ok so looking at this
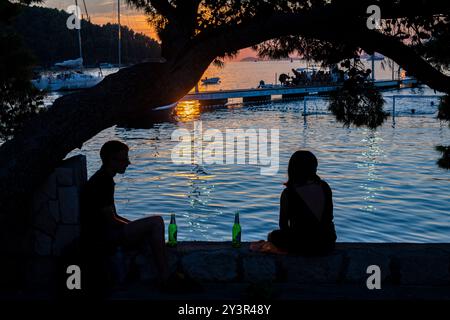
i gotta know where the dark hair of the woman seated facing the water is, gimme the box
[285,150,320,187]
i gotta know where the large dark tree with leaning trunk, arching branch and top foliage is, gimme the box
[0,0,450,284]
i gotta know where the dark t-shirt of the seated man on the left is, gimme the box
[81,167,123,249]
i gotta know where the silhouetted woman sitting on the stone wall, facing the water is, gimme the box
[268,151,336,255]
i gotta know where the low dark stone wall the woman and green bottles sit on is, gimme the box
[138,242,450,292]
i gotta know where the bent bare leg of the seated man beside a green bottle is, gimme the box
[124,216,169,281]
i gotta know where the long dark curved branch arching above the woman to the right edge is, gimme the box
[197,10,450,92]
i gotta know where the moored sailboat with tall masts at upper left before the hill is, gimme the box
[31,0,121,91]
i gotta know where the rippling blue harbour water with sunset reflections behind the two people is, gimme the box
[59,62,450,242]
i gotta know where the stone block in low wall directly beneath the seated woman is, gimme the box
[282,253,343,284]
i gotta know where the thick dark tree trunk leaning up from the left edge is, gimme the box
[0,51,214,255]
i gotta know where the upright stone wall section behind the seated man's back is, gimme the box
[29,155,87,286]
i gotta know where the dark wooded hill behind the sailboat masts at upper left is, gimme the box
[14,6,161,67]
